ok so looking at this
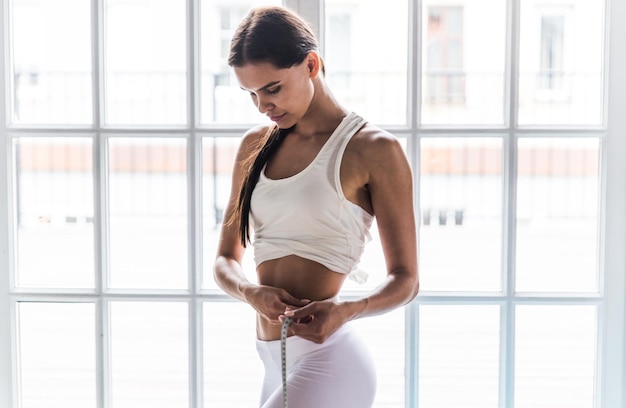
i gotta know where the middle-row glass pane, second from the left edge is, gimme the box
[109,138,188,289]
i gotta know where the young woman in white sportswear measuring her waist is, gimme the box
[214,7,418,408]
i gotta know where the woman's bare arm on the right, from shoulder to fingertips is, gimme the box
[285,128,419,343]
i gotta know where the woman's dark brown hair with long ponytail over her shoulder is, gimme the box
[228,7,324,247]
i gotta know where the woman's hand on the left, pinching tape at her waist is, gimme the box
[244,285,311,324]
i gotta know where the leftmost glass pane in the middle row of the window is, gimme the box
[14,137,95,288]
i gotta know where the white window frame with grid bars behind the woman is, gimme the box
[0,0,626,408]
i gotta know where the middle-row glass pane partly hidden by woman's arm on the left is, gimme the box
[202,137,256,289]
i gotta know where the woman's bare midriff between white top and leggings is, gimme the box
[257,255,346,341]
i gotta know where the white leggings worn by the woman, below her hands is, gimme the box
[257,323,376,408]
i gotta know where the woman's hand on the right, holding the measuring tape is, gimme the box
[279,300,348,344]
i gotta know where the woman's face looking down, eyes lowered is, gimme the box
[234,59,314,129]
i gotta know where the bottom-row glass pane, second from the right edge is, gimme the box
[418,305,500,408]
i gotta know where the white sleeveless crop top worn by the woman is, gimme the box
[250,113,374,283]
